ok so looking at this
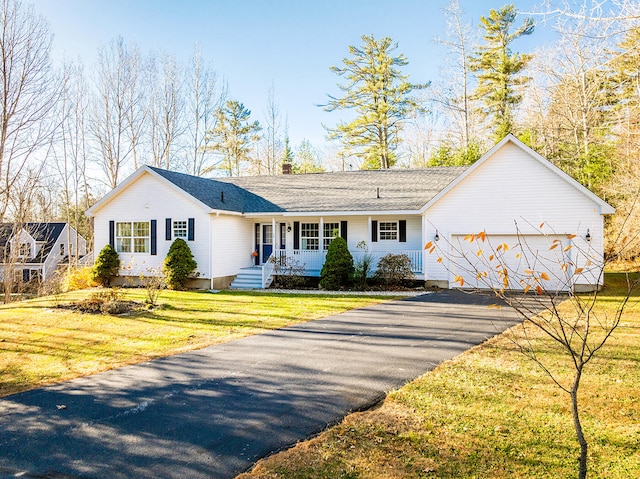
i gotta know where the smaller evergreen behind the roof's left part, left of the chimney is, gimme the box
[207,100,262,176]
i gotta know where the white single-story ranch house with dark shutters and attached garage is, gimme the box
[87,135,614,289]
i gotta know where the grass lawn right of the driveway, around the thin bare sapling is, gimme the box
[239,274,640,479]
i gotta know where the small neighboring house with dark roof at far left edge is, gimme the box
[0,222,87,282]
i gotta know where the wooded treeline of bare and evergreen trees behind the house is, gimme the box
[0,0,640,255]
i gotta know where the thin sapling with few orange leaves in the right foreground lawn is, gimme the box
[425,218,640,479]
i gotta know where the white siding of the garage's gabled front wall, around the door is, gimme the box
[424,143,603,286]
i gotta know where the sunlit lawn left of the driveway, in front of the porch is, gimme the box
[0,289,388,396]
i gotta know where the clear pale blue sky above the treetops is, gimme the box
[31,0,549,150]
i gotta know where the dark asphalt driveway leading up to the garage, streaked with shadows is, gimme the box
[0,291,516,479]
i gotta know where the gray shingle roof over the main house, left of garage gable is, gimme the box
[151,167,466,213]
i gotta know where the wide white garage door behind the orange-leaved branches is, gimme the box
[450,234,571,291]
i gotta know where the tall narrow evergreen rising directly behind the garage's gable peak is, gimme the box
[469,5,534,141]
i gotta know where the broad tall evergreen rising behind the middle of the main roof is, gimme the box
[324,35,426,169]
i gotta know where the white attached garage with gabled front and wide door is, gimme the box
[422,135,614,292]
